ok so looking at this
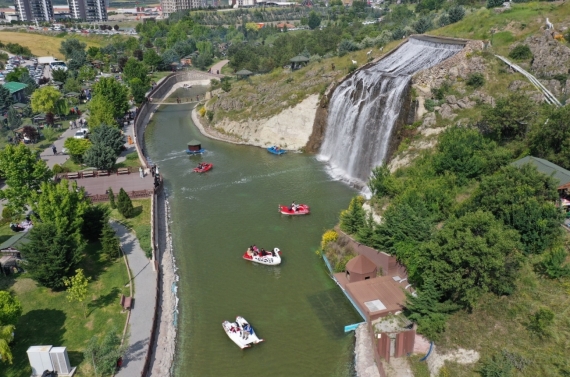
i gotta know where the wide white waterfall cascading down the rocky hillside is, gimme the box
[318,38,463,187]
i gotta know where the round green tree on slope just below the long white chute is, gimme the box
[482,92,538,140]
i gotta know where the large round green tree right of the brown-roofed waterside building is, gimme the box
[413,211,521,308]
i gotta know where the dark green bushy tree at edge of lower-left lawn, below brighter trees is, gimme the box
[21,223,83,289]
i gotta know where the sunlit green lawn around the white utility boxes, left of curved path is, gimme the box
[0,243,129,377]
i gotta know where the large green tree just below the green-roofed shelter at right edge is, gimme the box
[471,164,563,254]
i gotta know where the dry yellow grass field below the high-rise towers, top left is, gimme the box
[0,30,101,59]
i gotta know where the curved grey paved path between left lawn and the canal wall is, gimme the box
[112,223,157,377]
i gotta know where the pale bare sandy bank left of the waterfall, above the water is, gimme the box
[192,94,319,150]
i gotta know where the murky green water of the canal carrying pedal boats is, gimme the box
[145,88,361,377]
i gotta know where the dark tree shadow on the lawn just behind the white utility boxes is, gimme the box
[7,309,66,376]
